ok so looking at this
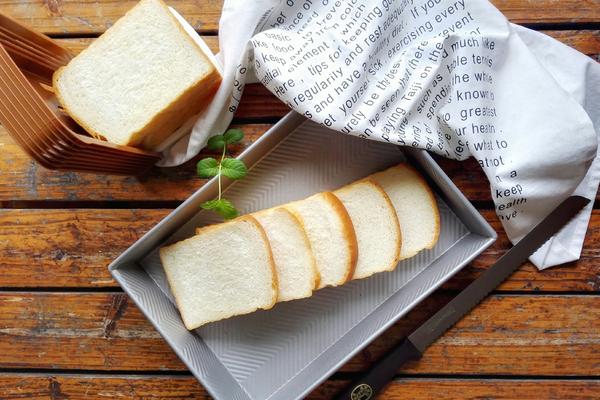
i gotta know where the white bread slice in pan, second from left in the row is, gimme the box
[252,207,320,301]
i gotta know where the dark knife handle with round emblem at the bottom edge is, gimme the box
[336,338,421,400]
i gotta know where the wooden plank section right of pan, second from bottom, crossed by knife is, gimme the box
[344,293,600,376]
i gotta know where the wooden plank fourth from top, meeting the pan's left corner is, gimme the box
[0,209,600,292]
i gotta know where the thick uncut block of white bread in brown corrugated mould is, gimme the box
[53,0,221,150]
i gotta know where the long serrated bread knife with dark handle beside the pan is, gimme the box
[336,196,590,400]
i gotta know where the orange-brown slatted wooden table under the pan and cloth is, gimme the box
[0,0,600,400]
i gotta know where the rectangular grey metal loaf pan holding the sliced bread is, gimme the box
[109,112,496,400]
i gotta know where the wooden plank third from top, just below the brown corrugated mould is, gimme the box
[0,125,600,203]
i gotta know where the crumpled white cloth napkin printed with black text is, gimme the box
[162,0,600,269]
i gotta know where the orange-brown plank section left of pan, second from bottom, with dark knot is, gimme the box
[0,293,184,371]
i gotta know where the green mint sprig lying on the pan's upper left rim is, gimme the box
[196,129,248,219]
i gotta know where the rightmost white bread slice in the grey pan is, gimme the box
[370,164,440,259]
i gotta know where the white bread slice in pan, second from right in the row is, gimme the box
[333,180,402,279]
